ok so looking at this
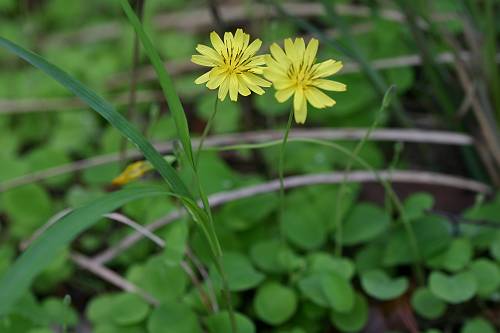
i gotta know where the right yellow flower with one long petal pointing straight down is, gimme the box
[264,38,346,124]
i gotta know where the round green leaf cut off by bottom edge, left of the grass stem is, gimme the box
[147,302,202,333]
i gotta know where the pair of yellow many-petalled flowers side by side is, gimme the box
[191,29,346,124]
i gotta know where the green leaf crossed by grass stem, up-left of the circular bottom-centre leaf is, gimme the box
[212,251,265,291]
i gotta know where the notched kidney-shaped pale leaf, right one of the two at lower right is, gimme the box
[429,271,477,304]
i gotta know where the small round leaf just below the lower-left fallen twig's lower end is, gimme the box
[111,293,149,326]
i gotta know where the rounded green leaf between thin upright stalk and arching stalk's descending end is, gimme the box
[342,203,390,245]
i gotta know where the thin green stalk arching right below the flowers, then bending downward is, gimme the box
[206,138,424,285]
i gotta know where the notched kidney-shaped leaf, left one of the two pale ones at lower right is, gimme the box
[361,269,408,301]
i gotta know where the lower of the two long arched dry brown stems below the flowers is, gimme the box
[94,170,491,264]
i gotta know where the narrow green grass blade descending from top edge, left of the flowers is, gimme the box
[121,0,195,169]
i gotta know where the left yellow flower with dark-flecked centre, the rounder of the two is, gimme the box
[191,29,271,101]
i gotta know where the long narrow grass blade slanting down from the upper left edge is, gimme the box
[0,37,192,199]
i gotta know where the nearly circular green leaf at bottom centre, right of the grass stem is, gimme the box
[253,283,297,326]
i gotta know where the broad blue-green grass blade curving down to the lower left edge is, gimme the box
[0,187,168,315]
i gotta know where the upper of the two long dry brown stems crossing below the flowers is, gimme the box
[0,128,474,193]
